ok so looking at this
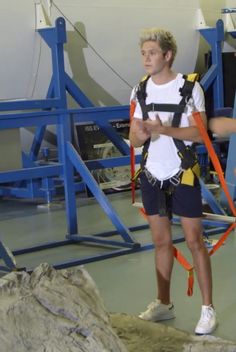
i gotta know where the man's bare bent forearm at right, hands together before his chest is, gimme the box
[143,112,207,143]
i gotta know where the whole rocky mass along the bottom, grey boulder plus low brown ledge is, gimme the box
[0,264,236,352]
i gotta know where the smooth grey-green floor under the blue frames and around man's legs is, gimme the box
[0,192,236,341]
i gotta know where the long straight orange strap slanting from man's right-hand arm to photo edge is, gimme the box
[193,112,236,216]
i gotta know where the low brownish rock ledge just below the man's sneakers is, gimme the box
[111,314,236,352]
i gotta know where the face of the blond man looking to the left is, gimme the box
[141,40,170,76]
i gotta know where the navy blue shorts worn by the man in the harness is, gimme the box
[140,172,203,218]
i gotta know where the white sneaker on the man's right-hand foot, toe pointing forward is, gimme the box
[195,306,217,335]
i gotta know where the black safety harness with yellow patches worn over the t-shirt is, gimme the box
[135,75,199,218]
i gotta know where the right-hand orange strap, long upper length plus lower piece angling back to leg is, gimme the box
[193,112,236,255]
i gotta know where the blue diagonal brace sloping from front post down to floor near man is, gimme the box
[67,143,135,243]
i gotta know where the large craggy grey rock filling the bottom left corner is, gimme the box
[0,264,127,352]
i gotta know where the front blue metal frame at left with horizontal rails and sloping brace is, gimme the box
[0,107,141,265]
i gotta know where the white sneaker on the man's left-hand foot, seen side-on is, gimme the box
[139,299,175,321]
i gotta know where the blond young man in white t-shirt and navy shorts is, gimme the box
[129,28,217,334]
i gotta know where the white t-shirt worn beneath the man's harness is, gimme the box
[131,73,205,181]
